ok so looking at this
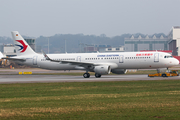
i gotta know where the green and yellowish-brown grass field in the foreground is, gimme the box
[0,80,180,120]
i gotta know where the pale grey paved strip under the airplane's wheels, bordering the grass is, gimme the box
[0,75,180,84]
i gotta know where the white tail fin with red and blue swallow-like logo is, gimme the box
[11,31,36,56]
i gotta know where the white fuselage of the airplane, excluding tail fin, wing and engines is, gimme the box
[17,52,179,70]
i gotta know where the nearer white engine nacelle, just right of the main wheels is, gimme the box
[94,66,111,75]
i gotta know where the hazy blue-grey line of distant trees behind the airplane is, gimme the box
[0,33,165,53]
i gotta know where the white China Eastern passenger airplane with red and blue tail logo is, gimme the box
[2,31,179,78]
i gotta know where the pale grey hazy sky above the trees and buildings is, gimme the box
[0,0,180,37]
